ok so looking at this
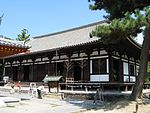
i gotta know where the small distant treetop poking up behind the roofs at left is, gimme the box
[16,29,30,43]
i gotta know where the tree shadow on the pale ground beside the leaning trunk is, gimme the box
[62,97,136,111]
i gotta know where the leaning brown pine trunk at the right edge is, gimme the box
[130,27,150,100]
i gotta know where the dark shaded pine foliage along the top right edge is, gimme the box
[88,0,150,20]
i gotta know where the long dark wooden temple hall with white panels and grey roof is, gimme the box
[0,21,143,91]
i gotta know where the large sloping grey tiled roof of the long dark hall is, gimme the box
[28,21,105,52]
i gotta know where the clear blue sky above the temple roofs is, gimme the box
[0,0,105,39]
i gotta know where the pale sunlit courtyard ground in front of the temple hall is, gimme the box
[0,88,150,113]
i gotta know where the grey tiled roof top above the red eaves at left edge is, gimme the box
[0,37,29,48]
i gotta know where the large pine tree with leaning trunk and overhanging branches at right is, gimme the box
[90,0,150,100]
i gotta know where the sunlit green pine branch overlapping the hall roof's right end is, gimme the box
[91,7,150,44]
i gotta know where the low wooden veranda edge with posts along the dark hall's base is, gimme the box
[59,82,134,91]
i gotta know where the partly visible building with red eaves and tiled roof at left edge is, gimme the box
[0,37,29,83]
